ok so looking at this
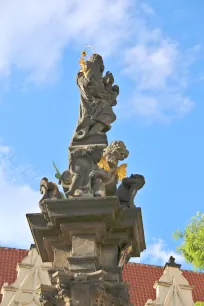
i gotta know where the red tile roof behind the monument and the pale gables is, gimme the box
[0,247,204,306]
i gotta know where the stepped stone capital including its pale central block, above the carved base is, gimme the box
[27,197,145,269]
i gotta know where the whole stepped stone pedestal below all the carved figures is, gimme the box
[27,197,145,306]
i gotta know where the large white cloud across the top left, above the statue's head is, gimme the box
[0,0,131,81]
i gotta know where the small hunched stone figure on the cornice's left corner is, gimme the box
[39,177,62,203]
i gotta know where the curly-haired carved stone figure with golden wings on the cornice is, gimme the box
[90,141,129,196]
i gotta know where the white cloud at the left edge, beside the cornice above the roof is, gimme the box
[0,141,40,248]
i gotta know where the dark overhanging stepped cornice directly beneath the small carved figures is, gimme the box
[27,197,145,261]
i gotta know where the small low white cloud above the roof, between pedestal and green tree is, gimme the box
[131,239,185,265]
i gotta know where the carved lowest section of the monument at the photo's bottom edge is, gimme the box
[38,271,131,306]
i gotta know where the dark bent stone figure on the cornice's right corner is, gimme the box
[116,174,145,207]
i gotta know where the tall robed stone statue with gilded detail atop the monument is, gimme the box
[71,54,119,146]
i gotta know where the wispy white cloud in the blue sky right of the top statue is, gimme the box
[123,11,200,122]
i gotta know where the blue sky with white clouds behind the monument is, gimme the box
[0,0,204,268]
